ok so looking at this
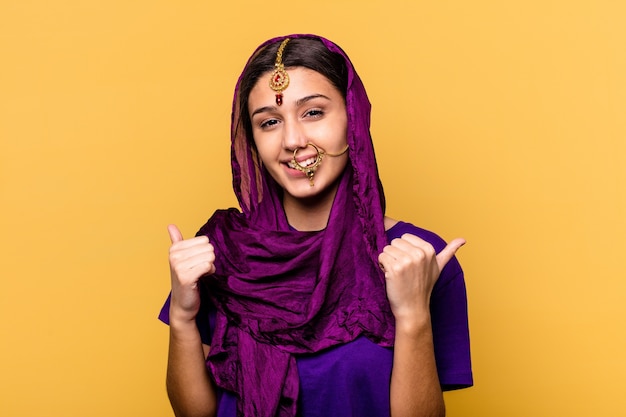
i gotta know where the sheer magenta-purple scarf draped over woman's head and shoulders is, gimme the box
[198,35,394,417]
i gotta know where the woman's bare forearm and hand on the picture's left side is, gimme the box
[166,225,217,417]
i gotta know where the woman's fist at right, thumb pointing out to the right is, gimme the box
[378,233,465,322]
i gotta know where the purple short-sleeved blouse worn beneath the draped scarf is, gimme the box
[159,222,473,417]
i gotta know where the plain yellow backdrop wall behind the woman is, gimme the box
[0,0,626,417]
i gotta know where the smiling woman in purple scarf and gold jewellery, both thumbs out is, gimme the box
[161,35,472,417]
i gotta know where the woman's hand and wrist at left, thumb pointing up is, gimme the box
[167,224,215,322]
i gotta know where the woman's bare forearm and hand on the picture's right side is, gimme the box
[379,234,465,417]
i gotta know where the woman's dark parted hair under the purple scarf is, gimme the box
[237,38,348,142]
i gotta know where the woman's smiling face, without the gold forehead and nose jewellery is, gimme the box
[248,67,348,204]
